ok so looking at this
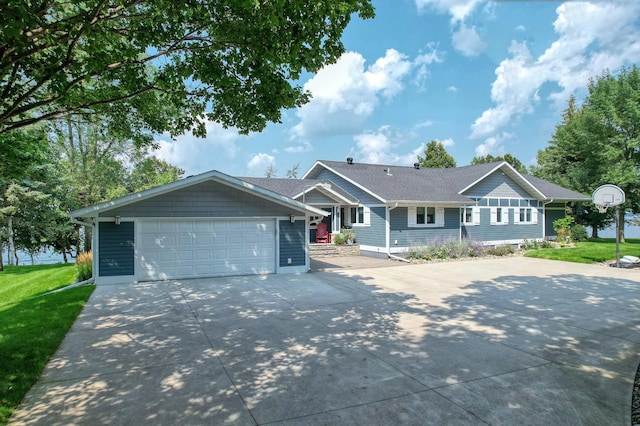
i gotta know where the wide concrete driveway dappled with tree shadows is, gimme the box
[12,257,640,425]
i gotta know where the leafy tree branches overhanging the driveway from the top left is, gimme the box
[0,0,374,142]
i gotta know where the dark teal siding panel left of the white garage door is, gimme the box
[98,222,134,277]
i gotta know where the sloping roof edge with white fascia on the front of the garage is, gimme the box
[70,170,328,218]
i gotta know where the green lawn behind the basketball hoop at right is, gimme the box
[525,238,640,263]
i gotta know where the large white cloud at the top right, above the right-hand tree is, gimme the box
[471,2,640,138]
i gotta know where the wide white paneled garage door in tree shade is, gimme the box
[138,219,276,281]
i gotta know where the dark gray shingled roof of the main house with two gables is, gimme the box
[303,160,590,205]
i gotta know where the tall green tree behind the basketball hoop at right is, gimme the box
[536,66,640,241]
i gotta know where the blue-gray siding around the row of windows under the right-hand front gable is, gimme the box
[462,208,543,242]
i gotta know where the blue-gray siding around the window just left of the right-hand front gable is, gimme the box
[390,207,460,247]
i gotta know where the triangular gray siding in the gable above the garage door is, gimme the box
[104,181,294,217]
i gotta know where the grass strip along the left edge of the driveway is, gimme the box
[0,264,93,425]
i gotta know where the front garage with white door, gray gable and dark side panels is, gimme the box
[71,170,327,285]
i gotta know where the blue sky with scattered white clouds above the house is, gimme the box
[155,0,640,177]
